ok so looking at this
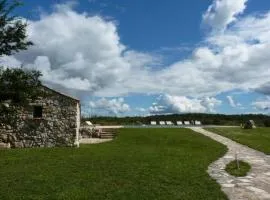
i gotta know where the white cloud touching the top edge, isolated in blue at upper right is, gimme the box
[203,0,247,30]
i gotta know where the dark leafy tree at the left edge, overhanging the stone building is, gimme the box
[0,0,41,125]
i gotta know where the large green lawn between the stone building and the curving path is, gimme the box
[0,129,227,200]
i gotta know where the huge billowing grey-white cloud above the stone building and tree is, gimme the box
[2,4,156,97]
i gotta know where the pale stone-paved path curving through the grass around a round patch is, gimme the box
[190,127,270,200]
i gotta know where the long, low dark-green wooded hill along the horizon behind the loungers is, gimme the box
[82,113,270,126]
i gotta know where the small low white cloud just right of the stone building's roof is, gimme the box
[89,98,130,115]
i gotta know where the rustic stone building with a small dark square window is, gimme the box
[0,86,80,148]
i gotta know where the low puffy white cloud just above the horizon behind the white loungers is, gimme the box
[149,94,221,114]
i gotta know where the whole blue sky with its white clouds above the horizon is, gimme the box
[3,0,270,116]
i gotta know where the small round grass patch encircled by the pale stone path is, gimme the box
[225,160,251,177]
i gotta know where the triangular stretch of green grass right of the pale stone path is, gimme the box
[206,127,270,154]
